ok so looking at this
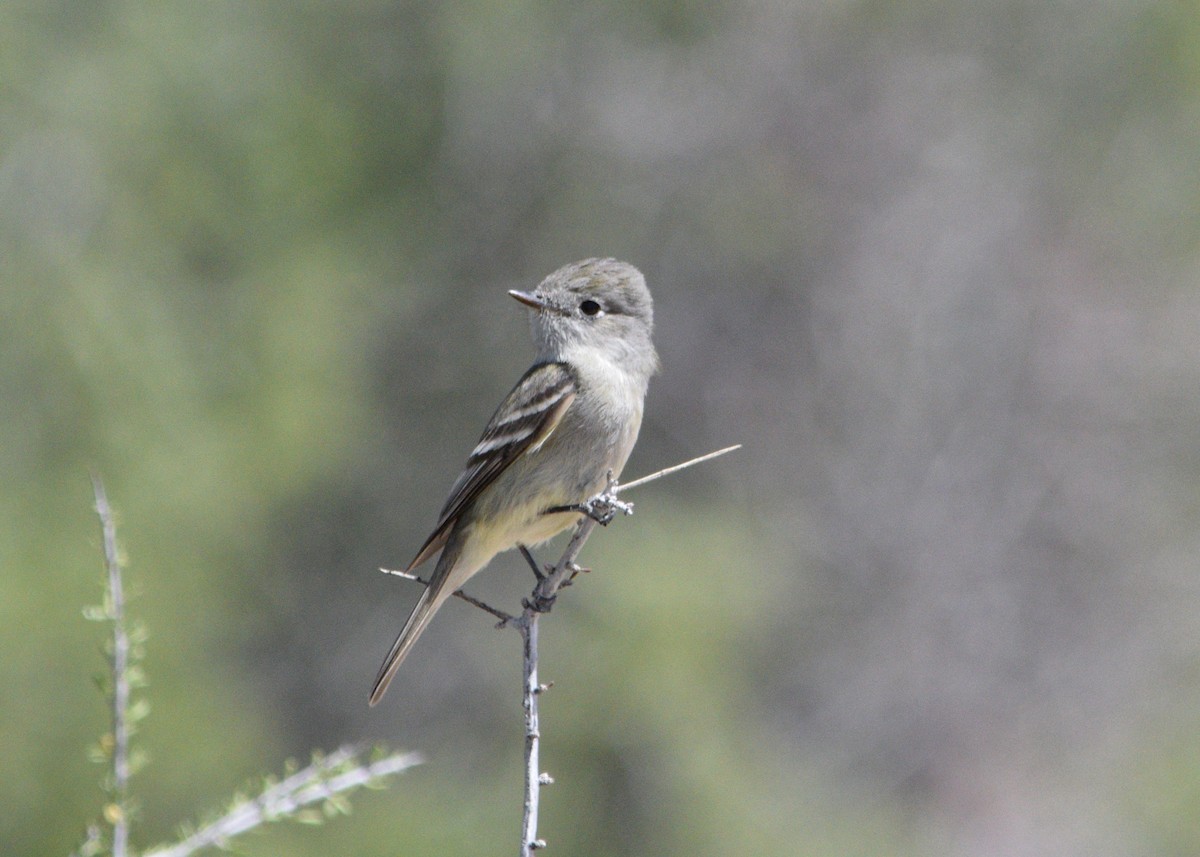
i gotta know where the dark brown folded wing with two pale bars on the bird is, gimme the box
[408,362,578,571]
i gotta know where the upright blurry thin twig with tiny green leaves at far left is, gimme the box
[91,474,130,857]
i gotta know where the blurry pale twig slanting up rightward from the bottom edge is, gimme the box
[145,747,421,857]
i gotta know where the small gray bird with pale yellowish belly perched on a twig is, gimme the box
[371,259,659,706]
